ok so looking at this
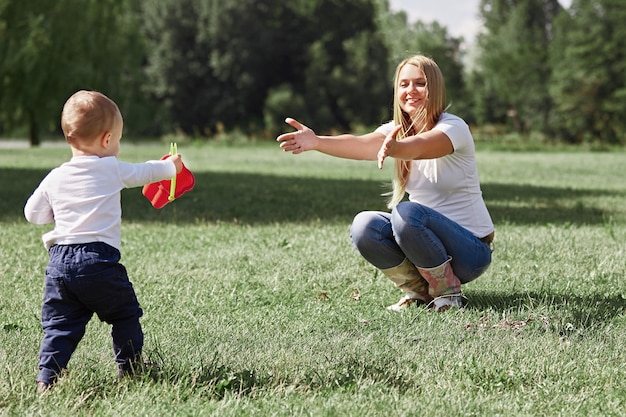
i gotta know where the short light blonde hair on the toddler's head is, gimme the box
[61,90,122,144]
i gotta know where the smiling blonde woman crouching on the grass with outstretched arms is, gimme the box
[276,55,494,311]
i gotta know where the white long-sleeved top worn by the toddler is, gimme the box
[24,156,176,250]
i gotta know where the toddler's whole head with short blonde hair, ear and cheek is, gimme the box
[61,90,123,156]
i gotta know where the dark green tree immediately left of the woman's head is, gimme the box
[298,0,391,131]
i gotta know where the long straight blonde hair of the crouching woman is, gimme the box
[387,55,446,208]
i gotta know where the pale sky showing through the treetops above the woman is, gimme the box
[389,0,572,43]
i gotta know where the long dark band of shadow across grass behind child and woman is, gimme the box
[0,168,619,225]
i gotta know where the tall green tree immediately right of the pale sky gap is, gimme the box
[472,0,561,133]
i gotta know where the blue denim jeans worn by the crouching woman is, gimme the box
[350,201,491,284]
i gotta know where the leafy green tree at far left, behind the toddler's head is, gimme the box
[0,0,144,146]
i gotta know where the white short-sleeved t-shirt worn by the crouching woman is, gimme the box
[376,113,494,238]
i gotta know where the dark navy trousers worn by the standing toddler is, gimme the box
[37,242,143,384]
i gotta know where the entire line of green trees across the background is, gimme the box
[0,0,626,145]
